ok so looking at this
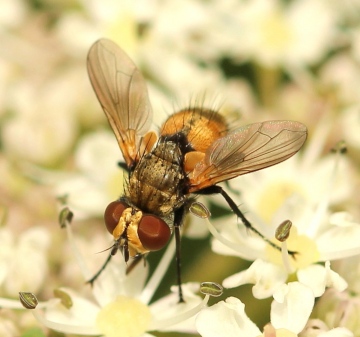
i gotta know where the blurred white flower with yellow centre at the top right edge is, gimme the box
[234,0,336,67]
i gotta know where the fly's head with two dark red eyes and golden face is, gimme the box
[104,200,171,262]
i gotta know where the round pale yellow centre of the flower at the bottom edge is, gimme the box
[96,296,151,337]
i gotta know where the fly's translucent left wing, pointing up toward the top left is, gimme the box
[87,39,152,167]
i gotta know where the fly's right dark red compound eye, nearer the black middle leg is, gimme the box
[138,215,171,250]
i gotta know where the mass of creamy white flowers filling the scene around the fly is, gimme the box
[0,0,360,337]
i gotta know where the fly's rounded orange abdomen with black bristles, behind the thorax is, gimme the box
[160,108,228,152]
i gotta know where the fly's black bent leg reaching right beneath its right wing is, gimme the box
[196,185,296,257]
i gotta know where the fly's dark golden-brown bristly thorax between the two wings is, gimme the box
[125,139,187,216]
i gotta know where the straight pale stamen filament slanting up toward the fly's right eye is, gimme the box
[140,237,175,303]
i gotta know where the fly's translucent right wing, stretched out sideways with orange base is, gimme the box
[189,121,307,192]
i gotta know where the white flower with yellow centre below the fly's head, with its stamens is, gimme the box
[0,219,209,337]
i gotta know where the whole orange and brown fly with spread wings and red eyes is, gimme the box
[87,39,307,302]
